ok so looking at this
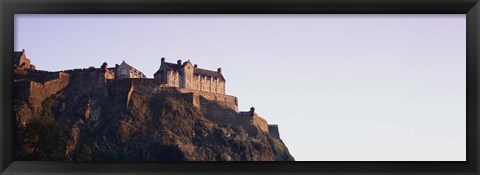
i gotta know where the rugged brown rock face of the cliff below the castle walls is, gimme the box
[15,76,294,161]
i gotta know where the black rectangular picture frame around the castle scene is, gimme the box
[0,0,480,175]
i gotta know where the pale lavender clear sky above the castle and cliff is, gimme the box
[14,14,466,161]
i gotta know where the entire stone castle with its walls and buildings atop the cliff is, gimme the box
[14,50,280,138]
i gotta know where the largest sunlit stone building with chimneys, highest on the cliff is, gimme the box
[154,58,225,94]
